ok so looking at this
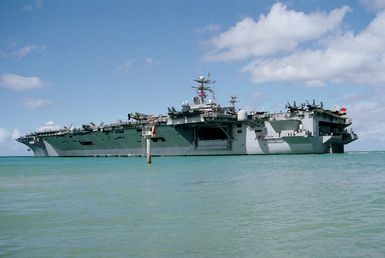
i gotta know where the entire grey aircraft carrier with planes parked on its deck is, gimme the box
[17,76,358,157]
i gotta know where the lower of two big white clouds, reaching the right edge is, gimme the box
[242,12,385,85]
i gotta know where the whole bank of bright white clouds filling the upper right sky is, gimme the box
[203,3,385,87]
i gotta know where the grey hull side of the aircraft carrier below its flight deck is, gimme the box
[18,121,355,157]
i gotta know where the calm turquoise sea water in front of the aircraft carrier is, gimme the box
[0,152,385,257]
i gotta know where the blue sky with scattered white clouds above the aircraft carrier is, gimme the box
[0,0,385,156]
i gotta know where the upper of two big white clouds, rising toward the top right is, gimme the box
[203,3,351,61]
